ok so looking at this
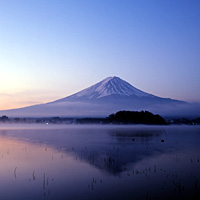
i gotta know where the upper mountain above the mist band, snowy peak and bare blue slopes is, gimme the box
[50,76,184,109]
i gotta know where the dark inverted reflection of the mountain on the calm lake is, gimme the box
[0,126,166,175]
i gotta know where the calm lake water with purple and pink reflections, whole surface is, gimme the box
[0,124,200,200]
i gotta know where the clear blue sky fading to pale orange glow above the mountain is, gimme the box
[0,0,200,110]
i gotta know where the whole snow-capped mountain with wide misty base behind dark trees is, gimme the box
[0,77,197,117]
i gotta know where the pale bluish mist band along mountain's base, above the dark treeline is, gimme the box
[0,102,200,118]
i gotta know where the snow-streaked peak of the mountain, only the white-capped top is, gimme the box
[70,76,153,99]
